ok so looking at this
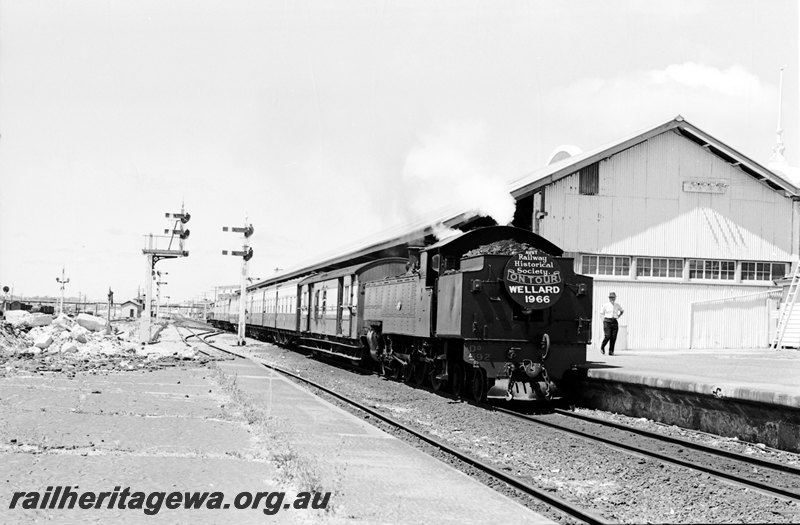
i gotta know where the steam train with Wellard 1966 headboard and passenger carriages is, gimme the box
[208,226,592,402]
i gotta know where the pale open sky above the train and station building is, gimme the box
[0,0,800,302]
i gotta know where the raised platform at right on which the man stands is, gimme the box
[578,349,800,452]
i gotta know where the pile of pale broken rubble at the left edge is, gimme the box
[0,311,204,377]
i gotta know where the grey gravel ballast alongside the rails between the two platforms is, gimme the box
[212,335,800,523]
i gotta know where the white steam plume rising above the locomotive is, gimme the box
[402,124,515,235]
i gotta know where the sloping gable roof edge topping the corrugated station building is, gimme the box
[510,115,800,199]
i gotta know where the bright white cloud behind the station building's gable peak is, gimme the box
[544,62,777,161]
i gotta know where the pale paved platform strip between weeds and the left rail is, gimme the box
[215,348,553,524]
